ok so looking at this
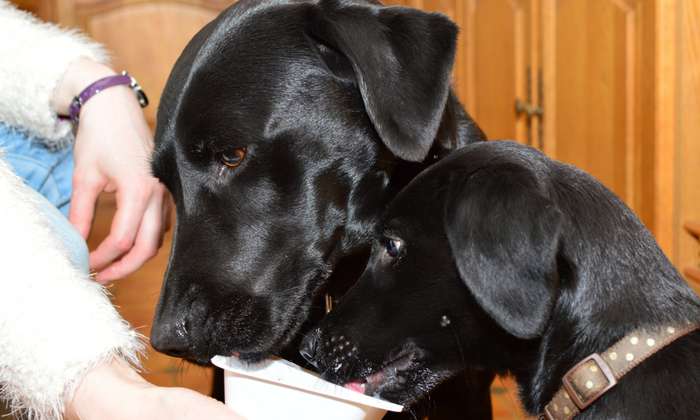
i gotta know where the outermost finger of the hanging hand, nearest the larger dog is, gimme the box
[96,194,164,284]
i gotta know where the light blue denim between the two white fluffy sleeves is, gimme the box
[0,123,89,272]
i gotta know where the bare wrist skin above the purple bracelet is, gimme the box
[51,58,116,115]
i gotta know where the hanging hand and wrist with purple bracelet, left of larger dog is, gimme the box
[53,59,170,283]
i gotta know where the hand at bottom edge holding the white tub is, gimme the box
[65,359,241,420]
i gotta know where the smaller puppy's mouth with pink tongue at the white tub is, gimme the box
[343,350,418,397]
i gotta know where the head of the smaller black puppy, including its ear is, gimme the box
[302,142,562,404]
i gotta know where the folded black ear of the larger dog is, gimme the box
[312,0,458,161]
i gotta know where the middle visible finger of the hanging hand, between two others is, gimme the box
[90,181,152,271]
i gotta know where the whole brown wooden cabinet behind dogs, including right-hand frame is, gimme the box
[387,0,700,289]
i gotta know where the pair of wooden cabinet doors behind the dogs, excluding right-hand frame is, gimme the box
[404,0,654,225]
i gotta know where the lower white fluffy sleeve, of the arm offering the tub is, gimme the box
[0,154,142,420]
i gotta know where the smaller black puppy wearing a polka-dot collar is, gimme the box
[303,142,700,420]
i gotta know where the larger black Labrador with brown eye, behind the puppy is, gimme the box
[151,0,493,418]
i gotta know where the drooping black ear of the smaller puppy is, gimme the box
[444,165,562,338]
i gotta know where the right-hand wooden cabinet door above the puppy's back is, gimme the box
[541,0,654,226]
